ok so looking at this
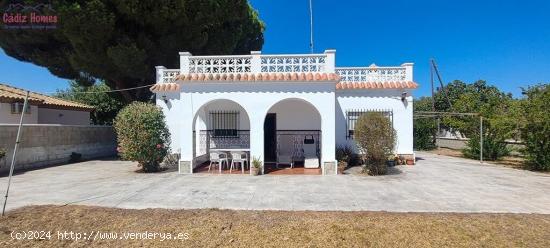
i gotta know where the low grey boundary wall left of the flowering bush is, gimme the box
[0,124,116,173]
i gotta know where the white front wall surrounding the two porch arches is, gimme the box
[157,82,336,174]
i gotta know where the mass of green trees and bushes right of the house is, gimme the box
[414,80,550,170]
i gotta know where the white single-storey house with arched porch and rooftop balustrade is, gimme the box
[151,50,418,174]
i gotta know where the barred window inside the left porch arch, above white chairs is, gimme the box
[210,110,240,137]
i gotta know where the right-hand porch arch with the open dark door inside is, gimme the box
[264,98,322,174]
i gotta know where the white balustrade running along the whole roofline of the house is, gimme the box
[157,50,413,83]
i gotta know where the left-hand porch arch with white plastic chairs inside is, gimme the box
[193,99,250,173]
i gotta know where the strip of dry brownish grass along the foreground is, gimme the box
[0,206,550,247]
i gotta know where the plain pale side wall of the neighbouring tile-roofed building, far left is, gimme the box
[38,108,90,125]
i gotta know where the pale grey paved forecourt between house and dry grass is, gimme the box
[0,153,550,214]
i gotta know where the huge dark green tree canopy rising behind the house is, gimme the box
[0,0,264,101]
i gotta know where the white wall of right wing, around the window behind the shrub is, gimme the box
[336,90,414,154]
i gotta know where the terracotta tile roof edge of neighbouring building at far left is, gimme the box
[0,83,94,111]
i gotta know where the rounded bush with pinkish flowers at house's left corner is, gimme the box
[114,102,170,172]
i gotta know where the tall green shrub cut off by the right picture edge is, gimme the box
[521,84,550,171]
